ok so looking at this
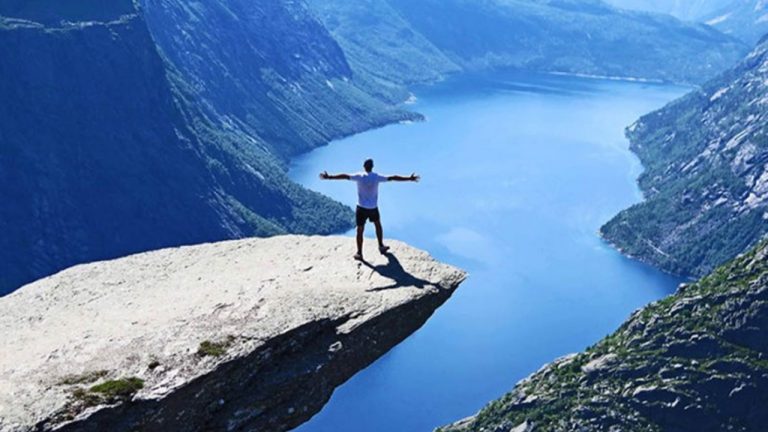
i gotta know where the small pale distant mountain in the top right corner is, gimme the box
[702,0,768,44]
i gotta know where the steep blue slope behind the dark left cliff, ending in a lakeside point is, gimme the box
[142,0,414,157]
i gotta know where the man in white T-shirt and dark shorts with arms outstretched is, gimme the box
[320,159,419,261]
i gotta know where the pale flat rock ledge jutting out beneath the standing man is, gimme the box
[0,236,465,432]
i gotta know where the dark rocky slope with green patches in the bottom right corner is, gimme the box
[442,244,768,432]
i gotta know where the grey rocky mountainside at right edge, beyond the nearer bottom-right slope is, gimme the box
[601,40,768,275]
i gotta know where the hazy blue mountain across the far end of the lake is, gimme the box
[311,0,746,83]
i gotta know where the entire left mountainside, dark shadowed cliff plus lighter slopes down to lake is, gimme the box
[0,0,414,294]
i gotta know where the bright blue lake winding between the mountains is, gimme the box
[290,74,687,432]
